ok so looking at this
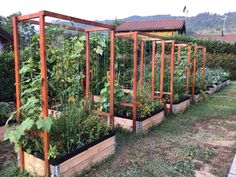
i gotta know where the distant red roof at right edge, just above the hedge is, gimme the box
[195,34,236,42]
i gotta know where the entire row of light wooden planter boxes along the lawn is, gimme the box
[0,80,230,176]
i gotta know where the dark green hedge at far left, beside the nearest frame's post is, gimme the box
[0,46,15,102]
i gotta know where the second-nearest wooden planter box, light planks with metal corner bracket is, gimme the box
[114,111,165,133]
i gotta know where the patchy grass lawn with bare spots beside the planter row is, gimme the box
[0,82,236,177]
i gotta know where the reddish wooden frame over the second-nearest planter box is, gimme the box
[115,31,168,132]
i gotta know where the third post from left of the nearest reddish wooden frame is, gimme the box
[85,31,90,111]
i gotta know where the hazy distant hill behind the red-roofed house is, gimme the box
[102,12,236,34]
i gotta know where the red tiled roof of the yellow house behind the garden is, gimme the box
[116,20,185,32]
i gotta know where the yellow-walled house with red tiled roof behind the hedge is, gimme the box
[116,20,186,36]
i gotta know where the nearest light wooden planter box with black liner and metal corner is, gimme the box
[21,132,116,177]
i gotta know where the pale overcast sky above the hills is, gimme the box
[0,0,236,20]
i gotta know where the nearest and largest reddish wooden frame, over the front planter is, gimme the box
[12,11,115,177]
